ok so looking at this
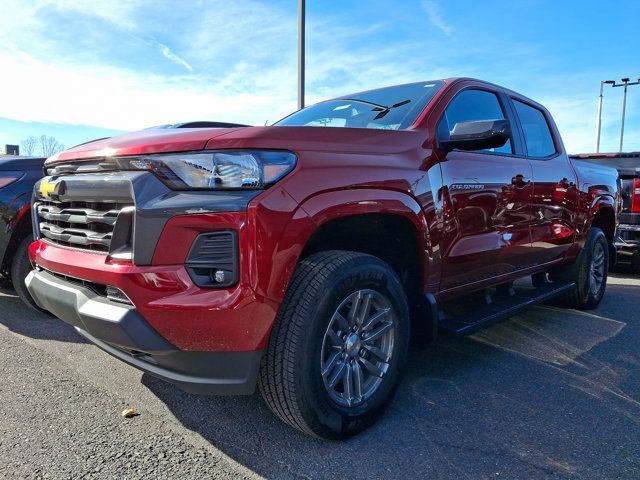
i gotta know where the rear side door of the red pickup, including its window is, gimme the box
[511,98,579,263]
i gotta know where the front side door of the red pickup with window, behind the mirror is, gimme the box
[436,86,533,290]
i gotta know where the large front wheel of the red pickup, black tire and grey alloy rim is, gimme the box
[258,250,410,439]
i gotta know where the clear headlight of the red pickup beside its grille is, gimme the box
[117,150,296,190]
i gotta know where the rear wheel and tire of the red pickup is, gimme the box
[551,227,609,310]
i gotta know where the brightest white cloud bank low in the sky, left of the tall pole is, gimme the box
[0,49,294,130]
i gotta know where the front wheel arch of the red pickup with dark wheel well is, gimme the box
[256,189,431,342]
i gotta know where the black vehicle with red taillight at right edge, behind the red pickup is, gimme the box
[572,152,640,274]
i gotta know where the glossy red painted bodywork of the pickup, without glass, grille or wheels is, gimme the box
[36,79,617,351]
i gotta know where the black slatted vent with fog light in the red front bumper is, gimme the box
[186,230,238,288]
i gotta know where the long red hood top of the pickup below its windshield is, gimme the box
[47,126,424,164]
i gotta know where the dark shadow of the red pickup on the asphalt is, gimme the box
[142,287,640,479]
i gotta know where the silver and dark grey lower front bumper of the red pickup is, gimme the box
[26,270,262,395]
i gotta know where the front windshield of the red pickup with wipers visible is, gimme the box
[275,81,442,130]
